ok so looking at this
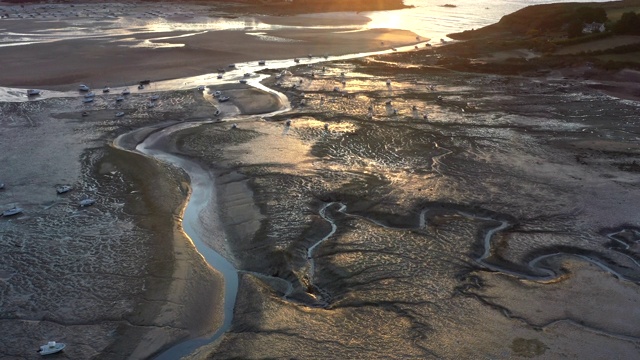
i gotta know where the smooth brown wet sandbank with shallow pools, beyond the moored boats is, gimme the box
[0,5,416,90]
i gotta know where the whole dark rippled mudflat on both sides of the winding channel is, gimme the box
[0,1,640,359]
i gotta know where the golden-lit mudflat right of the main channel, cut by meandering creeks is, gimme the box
[158,52,640,359]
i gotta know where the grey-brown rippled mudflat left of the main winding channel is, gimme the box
[0,86,222,359]
